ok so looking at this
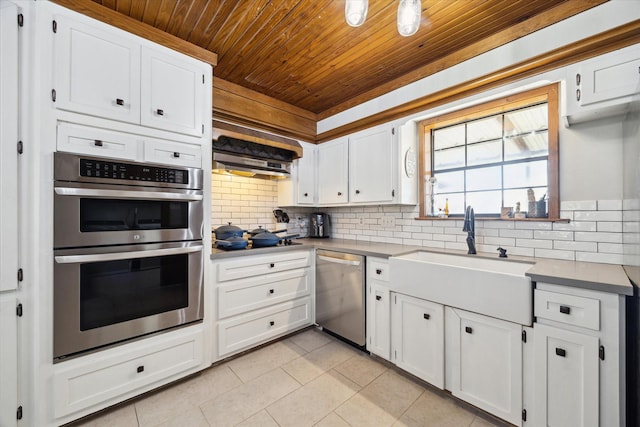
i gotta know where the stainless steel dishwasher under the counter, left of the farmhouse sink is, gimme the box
[316,249,366,347]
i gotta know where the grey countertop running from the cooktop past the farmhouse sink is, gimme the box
[211,238,633,295]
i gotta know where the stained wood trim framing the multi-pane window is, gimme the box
[416,83,567,222]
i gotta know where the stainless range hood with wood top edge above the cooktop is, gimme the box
[212,122,302,179]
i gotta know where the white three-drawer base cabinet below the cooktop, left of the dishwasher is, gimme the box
[214,250,315,360]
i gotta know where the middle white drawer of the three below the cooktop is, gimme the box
[218,268,311,319]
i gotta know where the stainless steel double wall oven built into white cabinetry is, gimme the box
[53,153,204,361]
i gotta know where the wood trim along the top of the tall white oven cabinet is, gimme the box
[53,0,218,67]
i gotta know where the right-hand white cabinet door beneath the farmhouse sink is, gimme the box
[445,307,522,425]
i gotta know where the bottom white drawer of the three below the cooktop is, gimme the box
[218,297,311,356]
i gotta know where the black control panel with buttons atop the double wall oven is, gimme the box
[80,159,189,184]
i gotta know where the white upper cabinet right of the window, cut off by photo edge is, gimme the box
[563,45,640,125]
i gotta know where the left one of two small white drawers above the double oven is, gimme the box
[56,123,138,160]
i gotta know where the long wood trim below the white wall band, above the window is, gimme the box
[316,20,640,143]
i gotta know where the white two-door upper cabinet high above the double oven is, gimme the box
[52,15,211,137]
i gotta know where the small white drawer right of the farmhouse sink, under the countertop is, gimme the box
[534,289,600,331]
